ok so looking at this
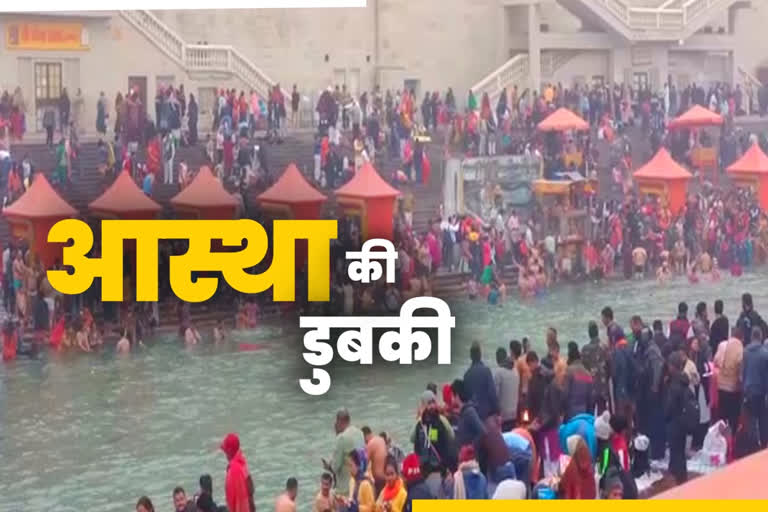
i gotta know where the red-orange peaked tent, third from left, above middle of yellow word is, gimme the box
[171,166,238,220]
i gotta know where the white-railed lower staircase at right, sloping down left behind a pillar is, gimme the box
[472,50,579,105]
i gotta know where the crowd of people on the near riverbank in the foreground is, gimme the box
[132,294,768,512]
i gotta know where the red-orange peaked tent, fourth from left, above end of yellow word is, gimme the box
[257,163,327,219]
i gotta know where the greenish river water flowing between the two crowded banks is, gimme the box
[0,274,768,512]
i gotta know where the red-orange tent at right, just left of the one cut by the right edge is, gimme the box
[632,148,693,214]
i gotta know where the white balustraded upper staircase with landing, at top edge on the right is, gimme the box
[558,0,739,41]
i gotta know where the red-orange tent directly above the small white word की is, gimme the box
[335,162,400,241]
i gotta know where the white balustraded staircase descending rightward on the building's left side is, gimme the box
[120,10,275,96]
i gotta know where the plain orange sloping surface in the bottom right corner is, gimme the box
[654,450,768,500]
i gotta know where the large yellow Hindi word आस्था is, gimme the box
[48,219,338,302]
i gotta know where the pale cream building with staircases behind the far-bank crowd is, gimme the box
[0,0,768,131]
